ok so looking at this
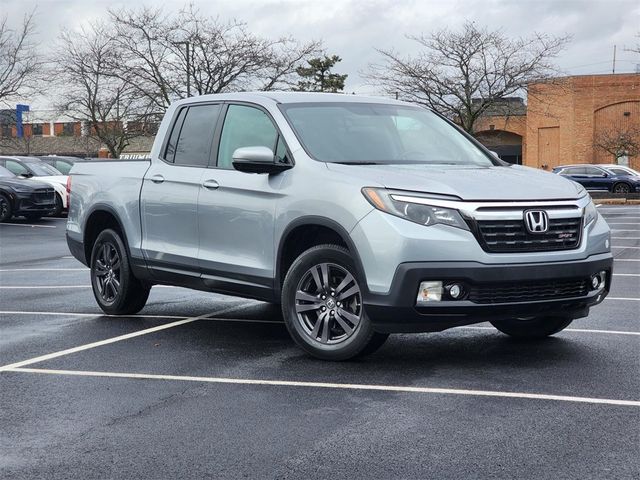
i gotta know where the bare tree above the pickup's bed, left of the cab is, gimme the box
[53,23,147,158]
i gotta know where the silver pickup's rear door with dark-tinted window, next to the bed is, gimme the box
[140,103,222,278]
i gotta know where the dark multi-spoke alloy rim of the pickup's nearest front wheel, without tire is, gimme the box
[295,263,363,345]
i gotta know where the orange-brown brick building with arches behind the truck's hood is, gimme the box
[476,74,640,170]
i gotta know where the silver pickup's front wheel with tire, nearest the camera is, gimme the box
[282,245,388,361]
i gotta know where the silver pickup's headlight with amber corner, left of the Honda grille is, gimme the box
[362,187,469,230]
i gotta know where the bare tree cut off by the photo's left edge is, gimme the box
[0,11,43,103]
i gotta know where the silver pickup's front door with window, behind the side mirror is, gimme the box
[198,104,290,297]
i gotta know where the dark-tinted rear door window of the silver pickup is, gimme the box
[166,105,221,167]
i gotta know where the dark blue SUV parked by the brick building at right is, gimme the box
[553,165,640,193]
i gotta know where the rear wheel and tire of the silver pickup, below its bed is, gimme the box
[91,229,151,315]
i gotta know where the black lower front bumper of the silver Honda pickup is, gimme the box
[364,253,613,333]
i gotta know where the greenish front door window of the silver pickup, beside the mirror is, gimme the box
[218,105,278,169]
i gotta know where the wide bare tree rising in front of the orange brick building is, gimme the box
[363,23,569,132]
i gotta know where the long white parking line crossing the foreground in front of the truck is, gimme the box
[7,367,640,407]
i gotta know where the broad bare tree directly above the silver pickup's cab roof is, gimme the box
[110,5,322,112]
